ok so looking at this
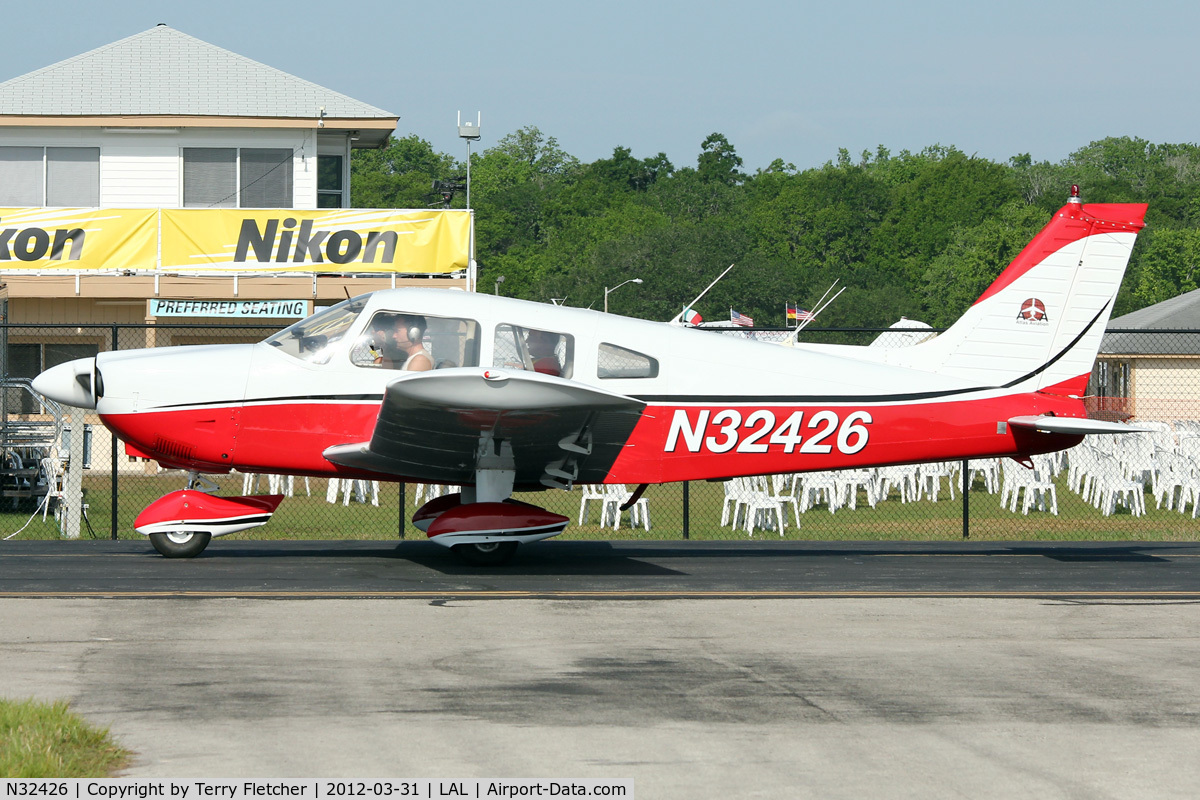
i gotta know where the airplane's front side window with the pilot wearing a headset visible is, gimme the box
[350,311,479,372]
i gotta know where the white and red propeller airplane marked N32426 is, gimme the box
[34,191,1146,564]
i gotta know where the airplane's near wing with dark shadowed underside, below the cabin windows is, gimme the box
[324,367,646,489]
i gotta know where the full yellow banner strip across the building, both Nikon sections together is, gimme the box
[0,207,470,275]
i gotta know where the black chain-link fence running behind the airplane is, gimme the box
[0,325,1200,541]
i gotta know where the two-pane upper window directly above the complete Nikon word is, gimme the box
[184,148,293,209]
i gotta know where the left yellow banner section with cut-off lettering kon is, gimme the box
[0,207,158,272]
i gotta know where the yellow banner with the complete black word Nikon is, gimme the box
[160,209,470,273]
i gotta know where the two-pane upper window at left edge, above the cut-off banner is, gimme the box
[0,148,100,207]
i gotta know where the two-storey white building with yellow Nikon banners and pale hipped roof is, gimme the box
[0,25,472,467]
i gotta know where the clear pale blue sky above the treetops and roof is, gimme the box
[7,0,1200,172]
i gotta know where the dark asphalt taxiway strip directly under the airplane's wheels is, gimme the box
[0,540,1200,600]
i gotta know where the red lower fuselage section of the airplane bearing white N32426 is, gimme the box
[103,393,1085,483]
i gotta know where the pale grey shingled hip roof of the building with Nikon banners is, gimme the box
[0,25,398,142]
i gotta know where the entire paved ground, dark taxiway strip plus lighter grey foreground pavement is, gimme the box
[0,541,1200,800]
